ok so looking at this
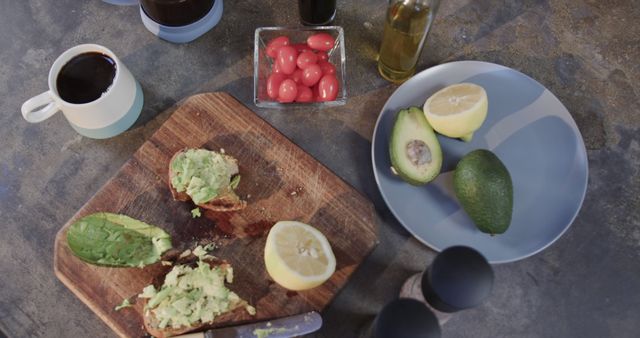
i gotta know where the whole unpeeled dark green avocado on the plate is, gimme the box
[453,149,513,235]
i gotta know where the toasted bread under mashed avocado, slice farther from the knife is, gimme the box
[169,148,247,212]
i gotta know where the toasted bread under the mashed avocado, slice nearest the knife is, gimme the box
[141,258,249,338]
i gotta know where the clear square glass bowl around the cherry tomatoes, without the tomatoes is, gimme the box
[253,26,347,108]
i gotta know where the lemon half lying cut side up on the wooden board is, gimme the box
[264,221,336,290]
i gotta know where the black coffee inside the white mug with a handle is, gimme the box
[56,52,116,103]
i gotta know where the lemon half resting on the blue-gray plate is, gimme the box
[423,83,489,141]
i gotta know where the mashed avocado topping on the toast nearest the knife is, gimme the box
[138,252,255,329]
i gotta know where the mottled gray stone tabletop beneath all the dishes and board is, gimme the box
[0,0,640,337]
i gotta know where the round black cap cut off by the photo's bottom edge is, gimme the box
[372,298,440,338]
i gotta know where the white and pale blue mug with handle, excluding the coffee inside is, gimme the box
[22,44,144,139]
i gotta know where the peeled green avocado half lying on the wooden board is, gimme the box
[67,212,171,267]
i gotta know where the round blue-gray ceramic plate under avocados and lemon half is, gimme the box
[372,61,588,263]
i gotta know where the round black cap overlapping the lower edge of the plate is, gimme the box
[422,246,493,312]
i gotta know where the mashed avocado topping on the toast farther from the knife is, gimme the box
[171,149,240,204]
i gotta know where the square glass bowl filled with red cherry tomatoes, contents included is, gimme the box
[253,26,347,108]
